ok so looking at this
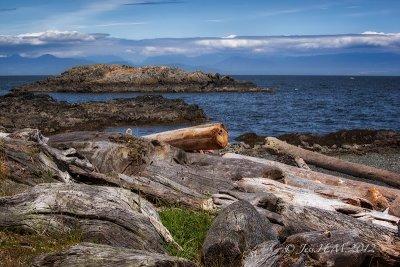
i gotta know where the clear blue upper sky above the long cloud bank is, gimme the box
[0,0,400,39]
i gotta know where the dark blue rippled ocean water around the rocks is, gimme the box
[0,76,400,137]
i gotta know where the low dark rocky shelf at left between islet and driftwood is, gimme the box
[0,93,206,134]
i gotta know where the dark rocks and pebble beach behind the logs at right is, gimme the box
[225,129,400,184]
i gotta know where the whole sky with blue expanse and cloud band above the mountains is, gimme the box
[0,0,400,60]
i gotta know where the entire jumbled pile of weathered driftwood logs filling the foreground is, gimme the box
[0,124,400,266]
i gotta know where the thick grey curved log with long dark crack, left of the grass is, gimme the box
[0,183,176,252]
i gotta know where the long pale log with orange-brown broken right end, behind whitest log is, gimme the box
[223,153,400,210]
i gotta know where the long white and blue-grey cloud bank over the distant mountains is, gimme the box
[0,30,400,59]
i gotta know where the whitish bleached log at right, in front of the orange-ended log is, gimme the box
[231,178,400,266]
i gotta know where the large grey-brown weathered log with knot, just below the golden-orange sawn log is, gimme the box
[50,132,282,209]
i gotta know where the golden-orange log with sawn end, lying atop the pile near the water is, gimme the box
[143,123,228,151]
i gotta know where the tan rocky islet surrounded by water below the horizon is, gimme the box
[14,64,261,92]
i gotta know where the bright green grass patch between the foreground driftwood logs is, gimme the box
[160,208,214,262]
